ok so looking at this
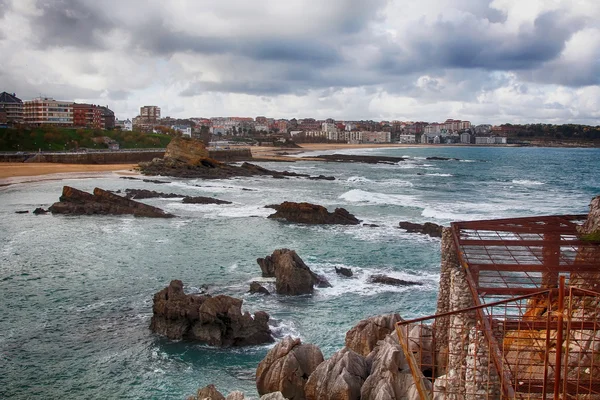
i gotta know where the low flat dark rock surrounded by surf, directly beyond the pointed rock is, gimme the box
[269,201,360,225]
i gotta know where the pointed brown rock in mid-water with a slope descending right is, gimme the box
[256,249,331,296]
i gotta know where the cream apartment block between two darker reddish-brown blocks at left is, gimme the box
[23,97,73,126]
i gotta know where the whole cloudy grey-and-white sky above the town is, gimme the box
[0,0,600,125]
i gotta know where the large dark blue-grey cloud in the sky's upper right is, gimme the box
[379,12,578,74]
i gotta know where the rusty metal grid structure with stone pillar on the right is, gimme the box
[396,215,600,400]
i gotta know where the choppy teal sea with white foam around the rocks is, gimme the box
[0,146,600,399]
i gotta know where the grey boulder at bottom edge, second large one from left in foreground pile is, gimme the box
[304,347,369,400]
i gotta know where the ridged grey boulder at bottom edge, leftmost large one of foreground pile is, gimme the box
[256,336,323,400]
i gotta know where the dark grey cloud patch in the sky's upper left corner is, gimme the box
[31,0,114,49]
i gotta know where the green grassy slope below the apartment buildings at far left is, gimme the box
[0,126,171,151]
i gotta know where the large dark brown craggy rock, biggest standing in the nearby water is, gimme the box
[150,280,274,347]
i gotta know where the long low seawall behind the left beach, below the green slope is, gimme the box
[0,148,252,164]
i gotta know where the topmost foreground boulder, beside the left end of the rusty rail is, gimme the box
[346,314,402,356]
